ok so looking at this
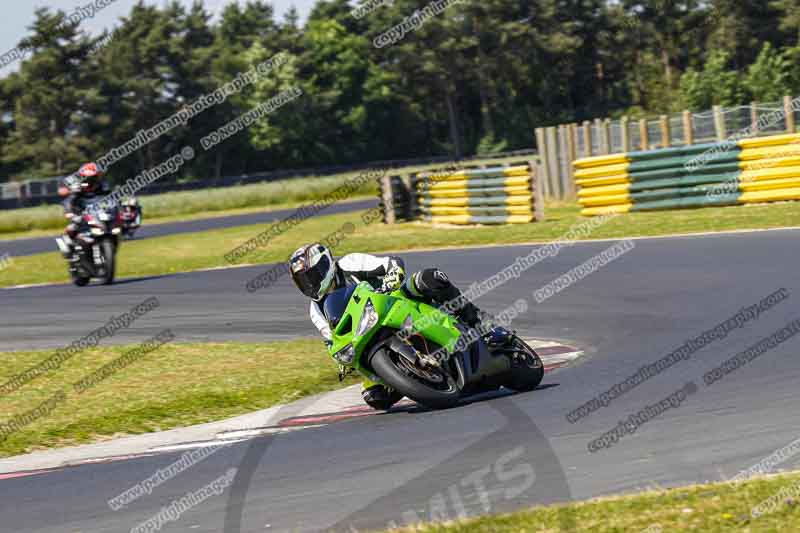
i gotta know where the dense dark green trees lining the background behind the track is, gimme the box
[0,0,800,181]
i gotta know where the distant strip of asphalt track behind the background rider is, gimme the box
[0,199,378,257]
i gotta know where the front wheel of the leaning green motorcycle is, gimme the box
[372,347,461,409]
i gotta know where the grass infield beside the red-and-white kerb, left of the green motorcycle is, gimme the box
[0,339,356,457]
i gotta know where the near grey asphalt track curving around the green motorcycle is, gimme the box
[0,230,800,533]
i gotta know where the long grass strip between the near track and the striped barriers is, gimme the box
[0,202,800,287]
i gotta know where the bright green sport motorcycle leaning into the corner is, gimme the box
[323,282,544,409]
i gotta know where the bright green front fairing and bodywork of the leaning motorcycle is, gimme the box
[324,281,461,384]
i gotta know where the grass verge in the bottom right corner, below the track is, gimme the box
[382,473,800,533]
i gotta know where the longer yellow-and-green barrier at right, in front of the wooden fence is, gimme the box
[574,134,800,216]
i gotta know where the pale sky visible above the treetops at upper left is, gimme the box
[0,0,315,76]
